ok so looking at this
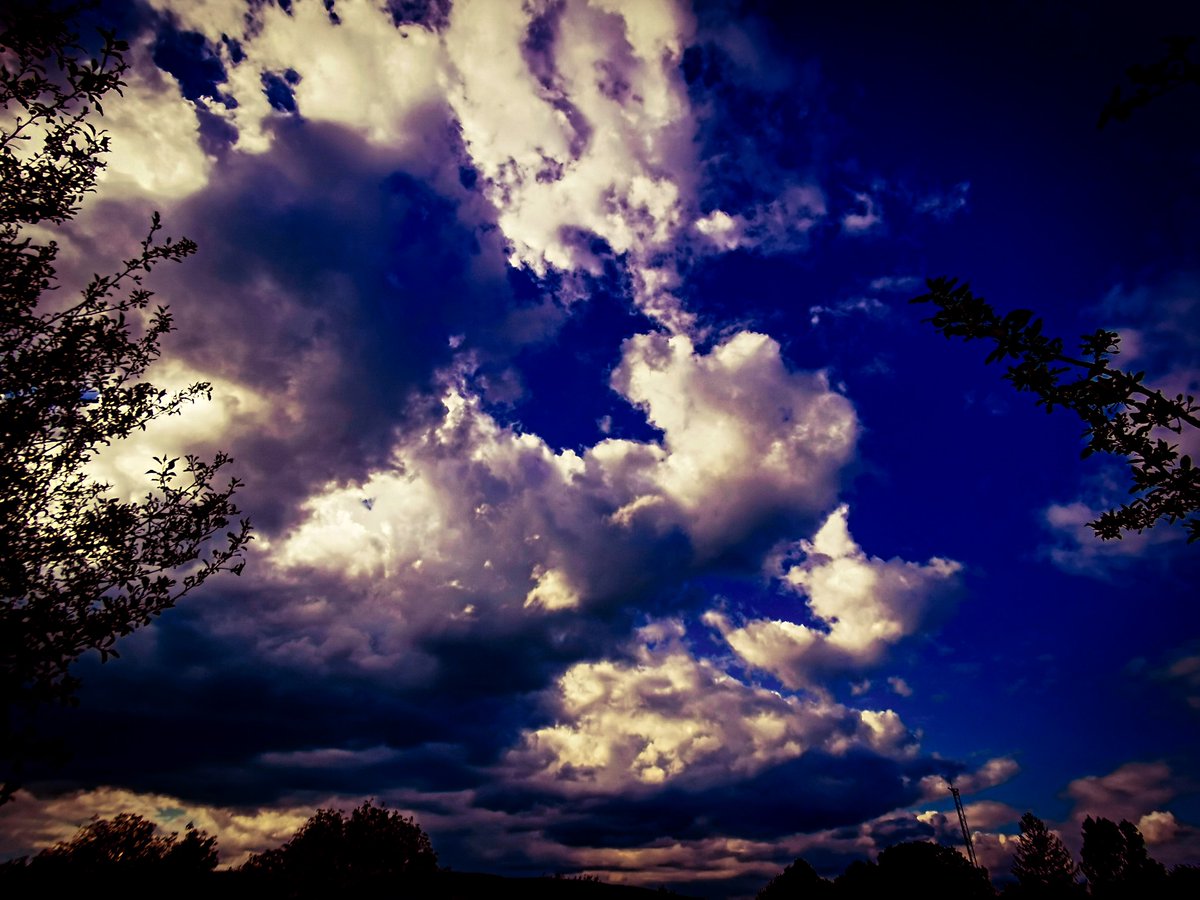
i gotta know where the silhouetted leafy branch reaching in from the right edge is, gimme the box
[912,278,1200,542]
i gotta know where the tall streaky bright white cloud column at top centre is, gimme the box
[445,0,695,319]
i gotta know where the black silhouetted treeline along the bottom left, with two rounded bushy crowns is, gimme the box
[0,800,677,900]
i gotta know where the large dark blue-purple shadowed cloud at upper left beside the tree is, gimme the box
[96,112,511,529]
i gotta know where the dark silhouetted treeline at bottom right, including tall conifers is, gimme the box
[757,812,1200,900]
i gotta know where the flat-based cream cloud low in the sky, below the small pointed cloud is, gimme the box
[505,622,912,794]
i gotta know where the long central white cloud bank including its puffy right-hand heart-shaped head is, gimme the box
[246,334,856,670]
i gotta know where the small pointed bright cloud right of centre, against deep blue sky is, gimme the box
[704,505,961,689]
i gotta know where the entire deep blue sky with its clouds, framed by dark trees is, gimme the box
[0,0,1200,898]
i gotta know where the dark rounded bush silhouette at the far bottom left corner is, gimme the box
[32,812,217,875]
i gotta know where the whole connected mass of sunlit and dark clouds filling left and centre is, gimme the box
[7,0,984,897]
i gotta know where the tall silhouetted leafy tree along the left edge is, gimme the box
[0,5,251,803]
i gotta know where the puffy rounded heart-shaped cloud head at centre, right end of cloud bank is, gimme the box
[613,332,857,553]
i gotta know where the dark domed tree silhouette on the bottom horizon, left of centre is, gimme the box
[242,800,438,895]
